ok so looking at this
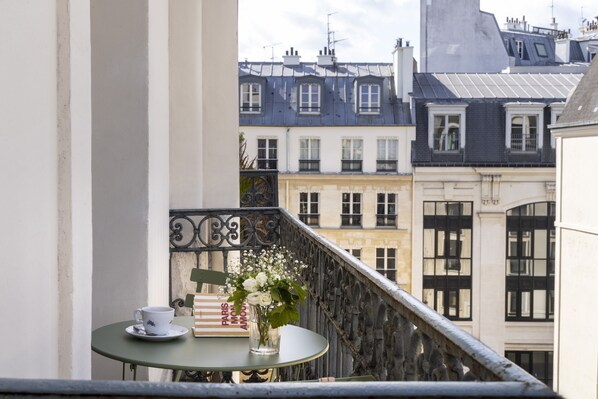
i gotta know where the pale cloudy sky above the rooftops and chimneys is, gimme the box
[238,0,598,62]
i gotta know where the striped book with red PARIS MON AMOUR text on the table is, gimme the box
[193,293,249,337]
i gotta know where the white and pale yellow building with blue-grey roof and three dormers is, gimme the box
[239,42,414,291]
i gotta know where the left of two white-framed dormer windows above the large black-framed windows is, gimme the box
[427,104,467,152]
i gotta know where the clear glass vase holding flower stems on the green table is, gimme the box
[249,305,280,355]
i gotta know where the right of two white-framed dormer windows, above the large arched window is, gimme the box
[505,103,545,153]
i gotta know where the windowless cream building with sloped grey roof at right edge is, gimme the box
[552,59,598,399]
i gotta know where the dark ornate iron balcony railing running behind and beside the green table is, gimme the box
[170,208,556,397]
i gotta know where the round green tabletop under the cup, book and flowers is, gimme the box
[91,316,328,380]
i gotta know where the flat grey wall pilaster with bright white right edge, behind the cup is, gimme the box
[91,0,169,379]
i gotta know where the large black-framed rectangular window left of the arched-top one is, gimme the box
[423,202,473,320]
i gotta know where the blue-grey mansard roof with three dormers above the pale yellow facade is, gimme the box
[239,62,412,126]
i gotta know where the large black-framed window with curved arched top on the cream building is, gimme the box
[505,202,555,321]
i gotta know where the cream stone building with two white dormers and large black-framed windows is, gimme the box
[412,73,580,384]
